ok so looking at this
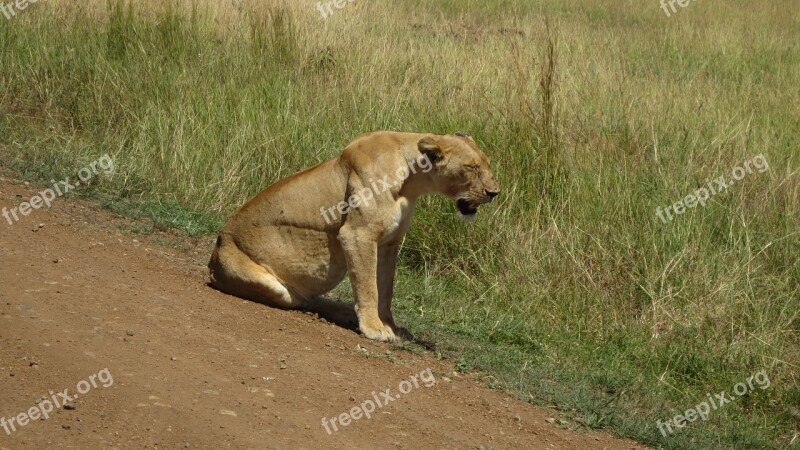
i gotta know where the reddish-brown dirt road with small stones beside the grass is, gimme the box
[0,173,643,449]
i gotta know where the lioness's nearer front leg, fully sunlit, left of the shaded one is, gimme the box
[339,227,397,342]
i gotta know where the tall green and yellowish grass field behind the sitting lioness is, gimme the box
[0,0,800,449]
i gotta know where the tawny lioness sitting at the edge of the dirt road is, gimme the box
[208,131,499,341]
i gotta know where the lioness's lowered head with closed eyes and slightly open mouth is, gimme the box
[417,132,500,220]
